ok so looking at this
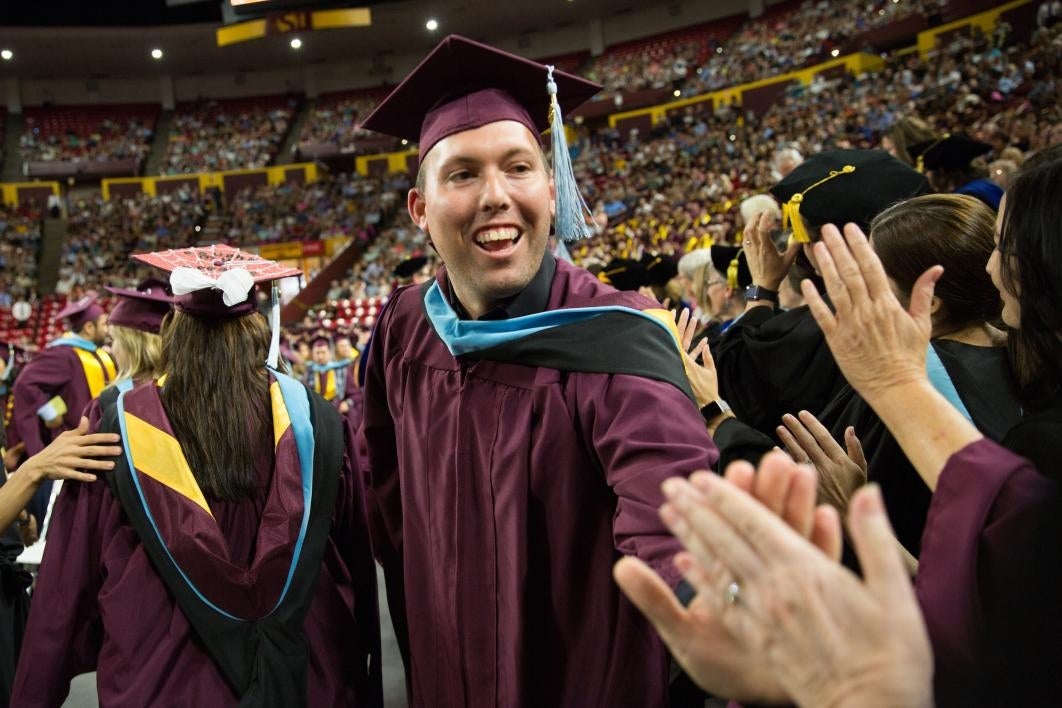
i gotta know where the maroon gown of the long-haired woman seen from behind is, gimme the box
[13,390,378,708]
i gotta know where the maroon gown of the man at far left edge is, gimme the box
[14,346,102,456]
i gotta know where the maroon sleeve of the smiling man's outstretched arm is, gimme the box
[580,374,719,587]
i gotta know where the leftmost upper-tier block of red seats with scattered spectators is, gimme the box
[19,105,158,161]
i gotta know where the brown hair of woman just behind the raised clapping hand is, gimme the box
[871,194,1003,336]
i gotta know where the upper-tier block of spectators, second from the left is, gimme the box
[161,96,298,174]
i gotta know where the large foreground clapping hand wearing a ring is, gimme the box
[649,462,932,708]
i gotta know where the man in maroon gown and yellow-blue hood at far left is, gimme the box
[14,293,117,523]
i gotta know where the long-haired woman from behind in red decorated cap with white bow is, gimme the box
[13,246,380,706]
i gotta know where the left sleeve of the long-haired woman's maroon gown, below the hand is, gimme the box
[11,481,111,707]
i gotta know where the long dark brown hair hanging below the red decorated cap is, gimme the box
[161,311,272,501]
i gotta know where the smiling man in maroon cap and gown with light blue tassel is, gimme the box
[359,37,716,707]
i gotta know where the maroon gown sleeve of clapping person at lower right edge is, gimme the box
[915,439,1062,708]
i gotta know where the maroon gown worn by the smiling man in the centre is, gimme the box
[359,262,717,708]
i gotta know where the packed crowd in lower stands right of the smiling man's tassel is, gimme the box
[573,16,1062,271]
